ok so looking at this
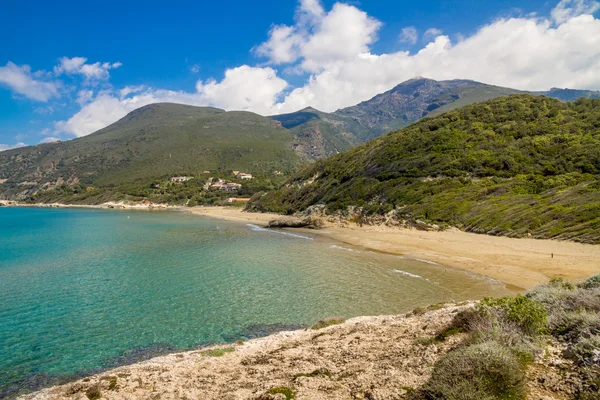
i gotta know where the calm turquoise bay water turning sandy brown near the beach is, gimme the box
[0,208,506,398]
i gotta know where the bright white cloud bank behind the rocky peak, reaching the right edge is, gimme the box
[266,3,600,113]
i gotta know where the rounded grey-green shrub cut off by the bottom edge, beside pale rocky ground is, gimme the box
[424,342,526,400]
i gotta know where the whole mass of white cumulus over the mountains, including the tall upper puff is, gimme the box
[57,0,600,136]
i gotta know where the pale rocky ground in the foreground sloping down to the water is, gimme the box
[21,303,570,400]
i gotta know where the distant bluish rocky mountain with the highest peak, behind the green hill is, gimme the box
[271,78,600,147]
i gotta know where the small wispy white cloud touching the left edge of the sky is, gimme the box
[0,61,60,102]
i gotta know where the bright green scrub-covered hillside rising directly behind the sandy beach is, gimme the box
[248,95,600,243]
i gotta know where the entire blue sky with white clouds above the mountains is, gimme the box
[0,0,600,151]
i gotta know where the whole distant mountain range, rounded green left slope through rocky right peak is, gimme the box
[0,78,600,203]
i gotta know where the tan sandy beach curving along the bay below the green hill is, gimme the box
[187,207,600,290]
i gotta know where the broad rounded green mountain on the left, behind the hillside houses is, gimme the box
[0,104,305,202]
